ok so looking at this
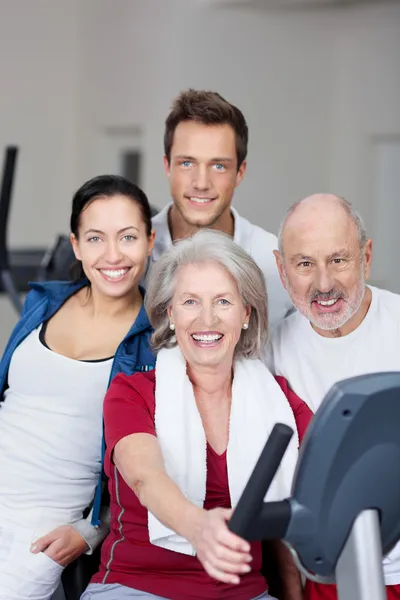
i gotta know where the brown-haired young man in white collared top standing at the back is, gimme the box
[147,90,292,324]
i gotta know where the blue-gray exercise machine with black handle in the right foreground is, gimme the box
[229,373,400,600]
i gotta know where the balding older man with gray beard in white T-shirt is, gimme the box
[267,194,400,600]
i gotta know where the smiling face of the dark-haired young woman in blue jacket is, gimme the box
[71,195,154,298]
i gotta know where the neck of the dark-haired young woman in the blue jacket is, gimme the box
[82,286,143,318]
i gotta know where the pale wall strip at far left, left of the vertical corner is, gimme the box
[0,0,79,349]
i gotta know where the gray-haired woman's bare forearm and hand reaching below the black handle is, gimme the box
[113,433,251,583]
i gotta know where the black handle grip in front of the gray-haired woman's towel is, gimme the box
[228,423,293,539]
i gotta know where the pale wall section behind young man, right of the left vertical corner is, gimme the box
[81,0,400,252]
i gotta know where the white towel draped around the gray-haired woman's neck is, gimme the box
[148,347,298,555]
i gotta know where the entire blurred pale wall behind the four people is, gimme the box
[0,0,400,345]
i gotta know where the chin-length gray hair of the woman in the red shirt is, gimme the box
[145,229,268,358]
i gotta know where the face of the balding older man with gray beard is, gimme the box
[277,205,371,331]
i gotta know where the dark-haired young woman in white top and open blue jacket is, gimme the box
[0,175,154,600]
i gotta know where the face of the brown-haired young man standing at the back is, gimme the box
[164,121,246,227]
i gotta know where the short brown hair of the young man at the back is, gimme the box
[164,89,249,168]
